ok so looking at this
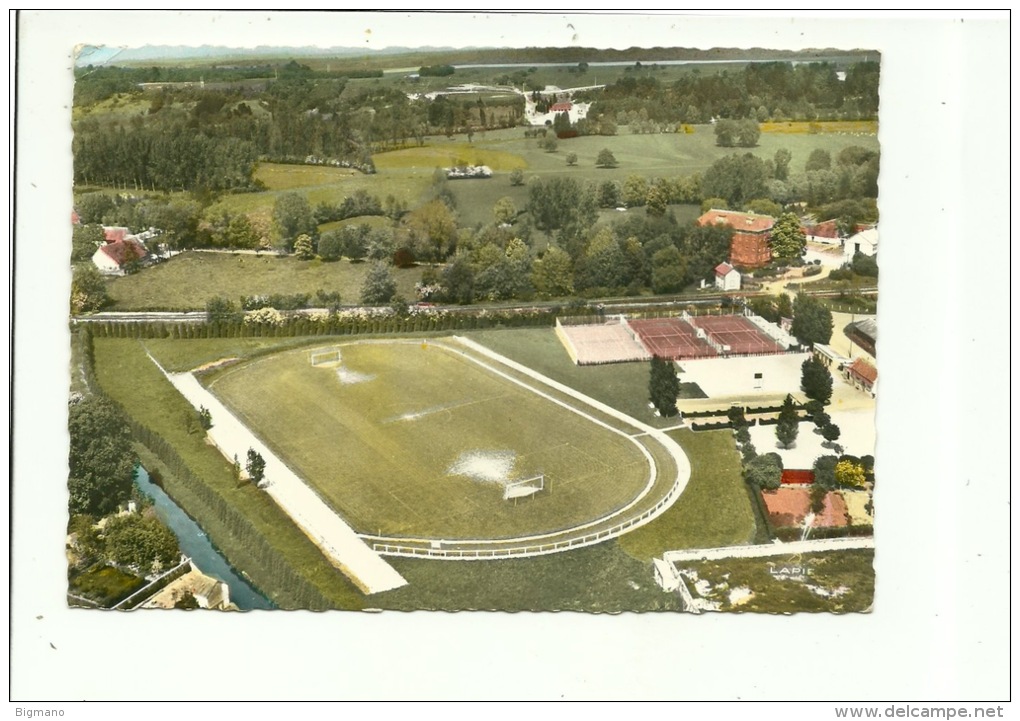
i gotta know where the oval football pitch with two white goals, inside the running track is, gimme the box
[209,342,650,538]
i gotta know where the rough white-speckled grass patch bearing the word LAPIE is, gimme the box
[677,550,875,614]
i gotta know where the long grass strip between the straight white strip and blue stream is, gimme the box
[88,339,364,609]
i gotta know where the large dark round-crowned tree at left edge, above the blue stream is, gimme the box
[67,396,135,517]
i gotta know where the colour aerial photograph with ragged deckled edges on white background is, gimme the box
[61,21,884,623]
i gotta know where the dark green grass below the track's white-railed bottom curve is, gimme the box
[369,542,680,613]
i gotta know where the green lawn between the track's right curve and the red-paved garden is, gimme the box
[619,428,756,561]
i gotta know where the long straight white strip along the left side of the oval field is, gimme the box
[161,369,407,594]
